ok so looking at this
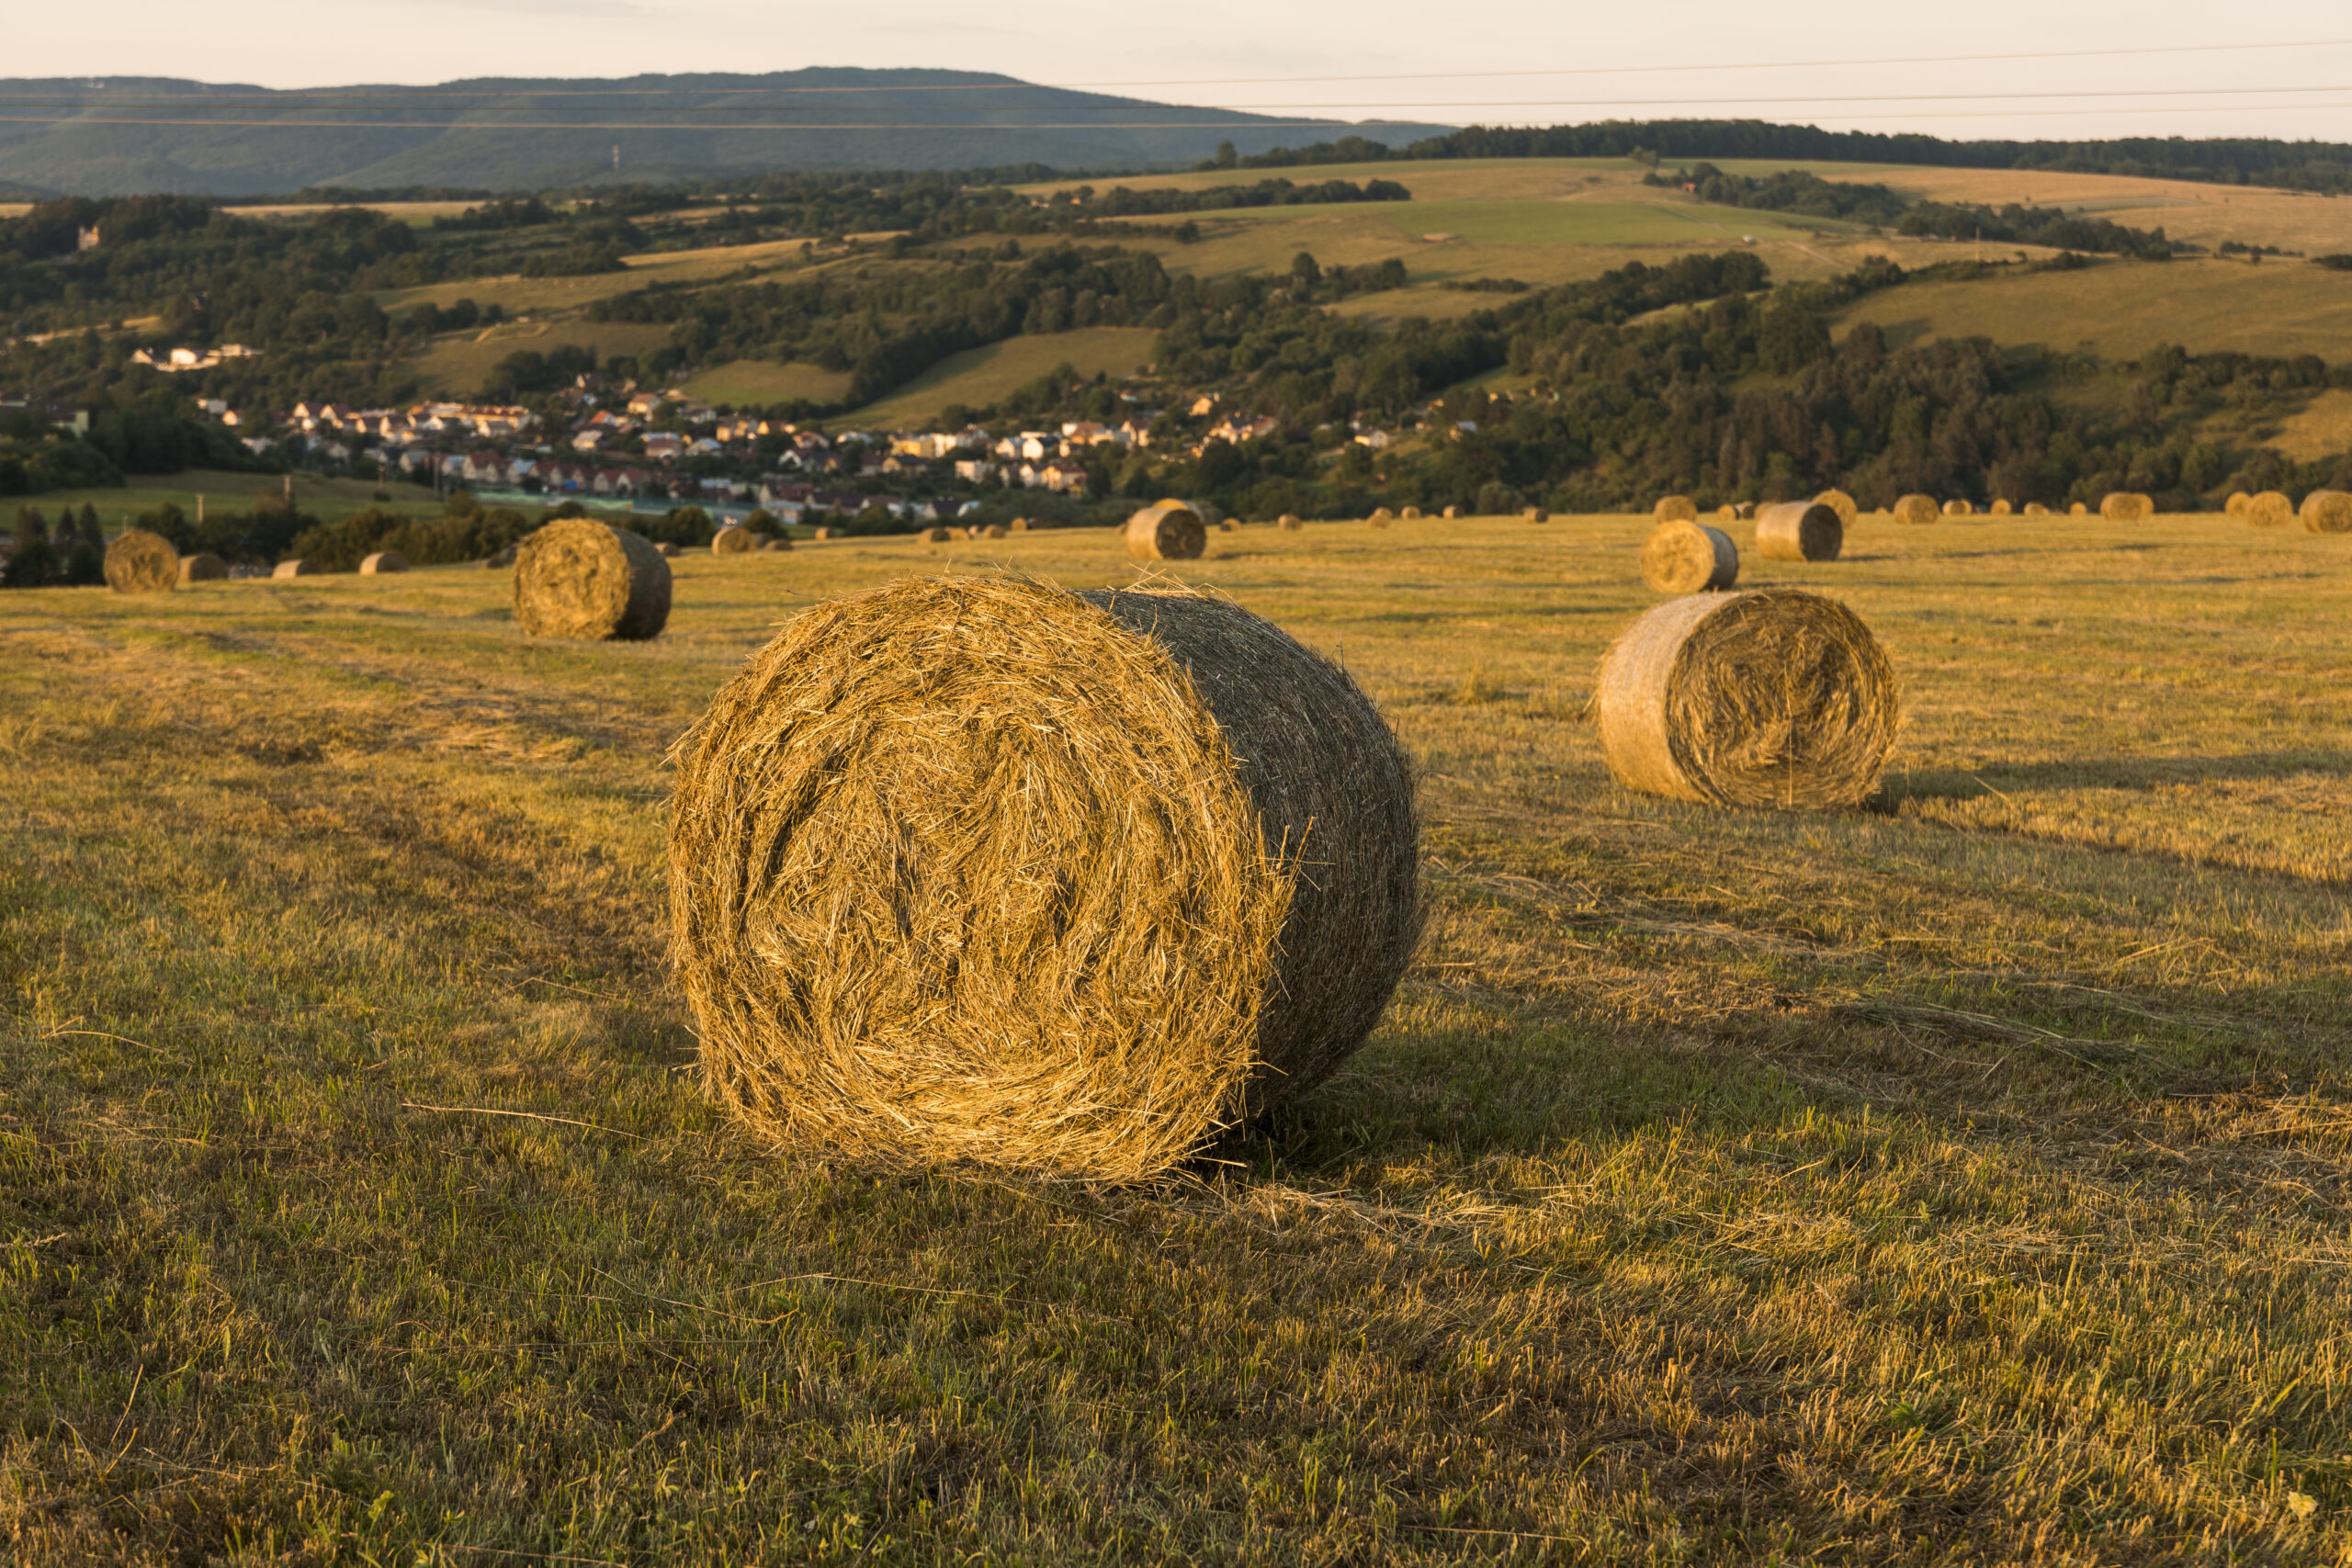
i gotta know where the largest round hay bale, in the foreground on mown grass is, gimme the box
[671,579,1420,1180]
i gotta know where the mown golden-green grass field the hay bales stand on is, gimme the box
[0,517,2352,1565]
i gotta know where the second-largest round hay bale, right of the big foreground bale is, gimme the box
[1595,588,1898,811]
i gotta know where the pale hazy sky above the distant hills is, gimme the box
[14,0,2352,141]
